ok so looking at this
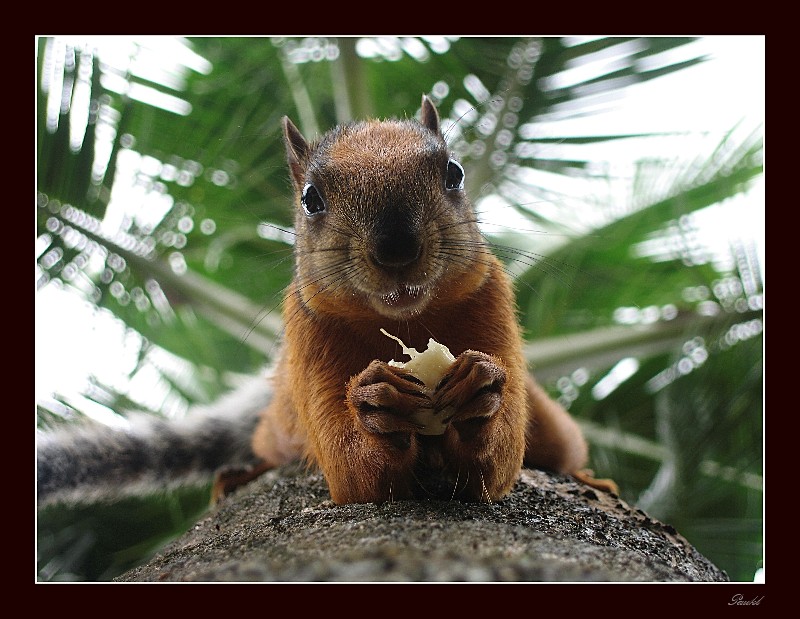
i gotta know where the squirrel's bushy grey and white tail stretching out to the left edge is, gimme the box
[36,377,270,507]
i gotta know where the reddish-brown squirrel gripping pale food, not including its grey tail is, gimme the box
[215,96,616,503]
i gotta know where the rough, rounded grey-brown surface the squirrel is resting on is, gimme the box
[116,466,728,582]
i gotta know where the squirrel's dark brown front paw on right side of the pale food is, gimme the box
[433,350,506,432]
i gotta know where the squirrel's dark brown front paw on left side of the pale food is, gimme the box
[347,360,433,435]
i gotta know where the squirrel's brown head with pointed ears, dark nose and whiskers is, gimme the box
[283,96,486,319]
